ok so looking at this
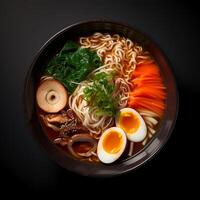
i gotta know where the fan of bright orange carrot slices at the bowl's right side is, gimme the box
[128,63,166,117]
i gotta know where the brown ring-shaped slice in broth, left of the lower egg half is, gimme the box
[67,133,97,158]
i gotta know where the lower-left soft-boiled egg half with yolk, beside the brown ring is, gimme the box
[97,127,127,164]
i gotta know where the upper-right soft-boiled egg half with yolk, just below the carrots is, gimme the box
[116,108,147,142]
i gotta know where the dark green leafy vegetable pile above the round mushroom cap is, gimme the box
[45,41,101,93]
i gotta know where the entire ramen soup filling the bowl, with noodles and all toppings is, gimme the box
[36,33,166,164]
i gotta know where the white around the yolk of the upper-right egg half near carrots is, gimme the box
[115,108,147,142]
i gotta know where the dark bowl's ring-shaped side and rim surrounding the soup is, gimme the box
[24,21,178,176]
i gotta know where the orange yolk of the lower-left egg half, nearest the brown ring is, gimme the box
[103,131,122,154]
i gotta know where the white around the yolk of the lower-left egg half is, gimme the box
[97,127,127,164]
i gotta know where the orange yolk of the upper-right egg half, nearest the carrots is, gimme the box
[119,112,140,134]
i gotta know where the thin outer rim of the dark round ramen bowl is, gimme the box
[23,19,179,177]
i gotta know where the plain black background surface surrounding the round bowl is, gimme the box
[0,0,200,195]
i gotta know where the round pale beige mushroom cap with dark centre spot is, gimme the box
[36,79,67,113]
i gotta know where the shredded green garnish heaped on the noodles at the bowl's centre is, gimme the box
[83,72,118,117]
